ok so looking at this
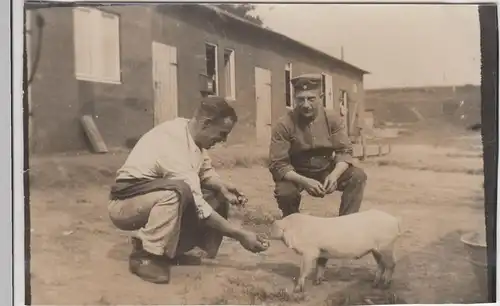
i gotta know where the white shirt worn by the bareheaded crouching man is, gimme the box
[117,118,218,219]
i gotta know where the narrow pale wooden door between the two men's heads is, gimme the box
[255,67,272,143]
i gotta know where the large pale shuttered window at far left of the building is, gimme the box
[73,7,121,83]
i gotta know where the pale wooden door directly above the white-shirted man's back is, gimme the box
[152,42,179,125]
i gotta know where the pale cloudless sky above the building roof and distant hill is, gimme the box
[252,4,481,89]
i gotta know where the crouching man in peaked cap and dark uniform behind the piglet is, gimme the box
[269,74,366,217]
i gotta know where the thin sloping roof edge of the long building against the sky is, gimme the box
[198,4,370,74]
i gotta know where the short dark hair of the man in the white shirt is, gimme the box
[195,96,238,123]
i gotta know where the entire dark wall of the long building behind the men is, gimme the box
[31,5,363,153]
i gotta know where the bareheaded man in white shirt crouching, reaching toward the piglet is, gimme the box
[108,97,268,283]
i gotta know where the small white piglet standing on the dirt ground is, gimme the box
[270,209,401,292]
